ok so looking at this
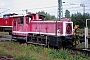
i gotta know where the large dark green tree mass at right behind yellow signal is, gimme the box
[71,12,90,28]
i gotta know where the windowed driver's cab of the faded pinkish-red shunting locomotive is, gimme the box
[12,14,45,40]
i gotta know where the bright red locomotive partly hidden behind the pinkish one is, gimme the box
[0,13,17,34]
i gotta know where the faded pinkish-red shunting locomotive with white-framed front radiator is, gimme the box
[12,14,73,48]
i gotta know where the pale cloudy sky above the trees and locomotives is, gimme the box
[0,0,90,17]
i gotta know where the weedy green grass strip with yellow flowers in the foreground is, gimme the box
[0,42,90,60]
